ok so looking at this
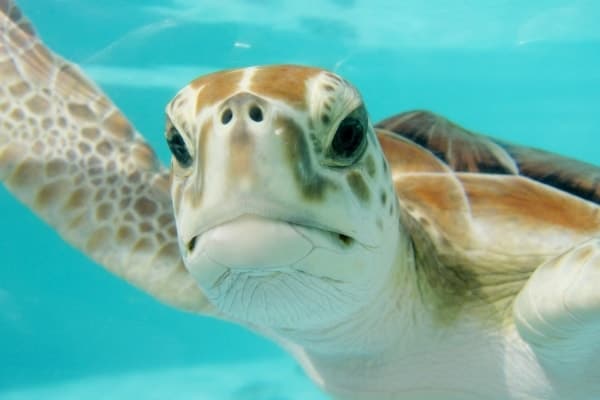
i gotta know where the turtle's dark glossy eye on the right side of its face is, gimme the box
[329,107,367,165]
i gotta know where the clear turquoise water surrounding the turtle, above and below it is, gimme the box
[0,0,600,400]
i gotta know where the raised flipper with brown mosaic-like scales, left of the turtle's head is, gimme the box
[0,0,209,312]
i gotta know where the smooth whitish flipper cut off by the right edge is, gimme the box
[514,238,600,363]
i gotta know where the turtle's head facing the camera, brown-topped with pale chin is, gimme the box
[166,66,398,329]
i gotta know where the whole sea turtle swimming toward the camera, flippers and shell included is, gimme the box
[0,0,600,400]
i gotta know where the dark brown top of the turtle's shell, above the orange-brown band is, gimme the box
[376,111,600,204]
